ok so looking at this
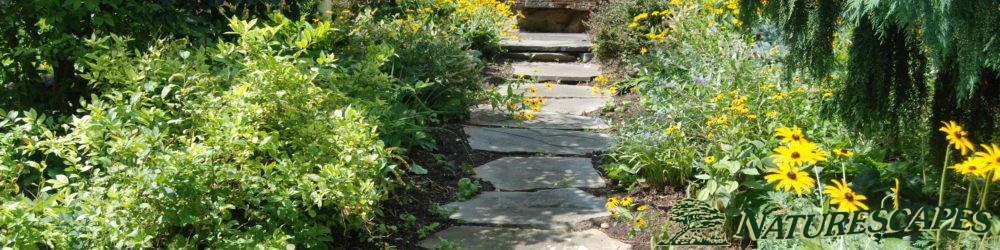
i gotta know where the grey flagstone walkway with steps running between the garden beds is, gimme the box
[420,33,630,250]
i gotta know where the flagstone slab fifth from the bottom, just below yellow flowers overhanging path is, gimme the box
[468,108,609,130]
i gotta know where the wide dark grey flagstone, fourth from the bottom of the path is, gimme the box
[464,126,612,155]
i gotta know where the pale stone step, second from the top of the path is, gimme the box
[511,62,601,82]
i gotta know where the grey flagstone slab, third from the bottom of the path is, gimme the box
[474,157,604,190]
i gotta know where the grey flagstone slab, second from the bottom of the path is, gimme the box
[445,188,611,229]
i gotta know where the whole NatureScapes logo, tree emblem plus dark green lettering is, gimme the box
[657,199,996,246]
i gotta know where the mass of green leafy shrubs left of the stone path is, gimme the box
[0,1,514,248]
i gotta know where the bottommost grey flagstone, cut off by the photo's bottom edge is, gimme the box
[420,226,632,250]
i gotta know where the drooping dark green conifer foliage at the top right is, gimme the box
[740,0,1000,158]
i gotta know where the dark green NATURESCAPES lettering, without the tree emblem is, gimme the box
[735,206,995,240]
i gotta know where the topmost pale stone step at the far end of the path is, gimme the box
[500,32,594,52]
